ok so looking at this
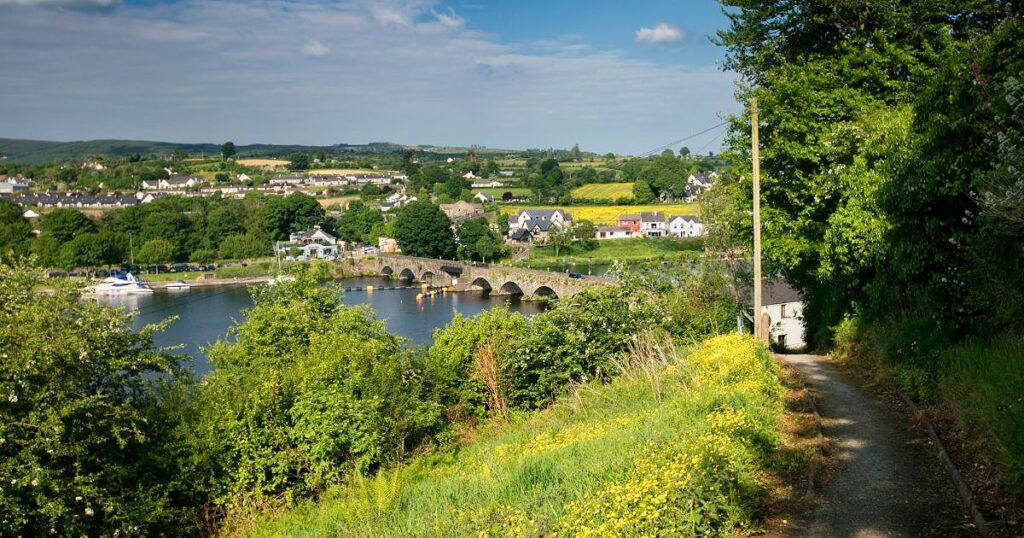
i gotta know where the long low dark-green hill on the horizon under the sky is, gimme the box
[0,138,520,164]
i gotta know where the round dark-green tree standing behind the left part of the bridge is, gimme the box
[394,200,456,259]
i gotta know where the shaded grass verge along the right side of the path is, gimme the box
[837,320,1024,526]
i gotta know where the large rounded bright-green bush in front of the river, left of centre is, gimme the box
[191,273,443,512]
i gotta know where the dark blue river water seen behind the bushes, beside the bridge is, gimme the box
[97,277,544,376]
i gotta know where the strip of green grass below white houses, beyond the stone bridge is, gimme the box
[517,238,703,268]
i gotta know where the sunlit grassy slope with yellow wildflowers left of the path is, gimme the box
[243,335,783,536]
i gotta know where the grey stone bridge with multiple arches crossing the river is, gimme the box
[348,254,615,297]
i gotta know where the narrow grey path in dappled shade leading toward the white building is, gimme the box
[780,355,974,538]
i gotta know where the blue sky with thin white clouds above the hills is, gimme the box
[0,0,739,155]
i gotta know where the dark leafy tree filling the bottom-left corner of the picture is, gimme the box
[0,259,193,536]
